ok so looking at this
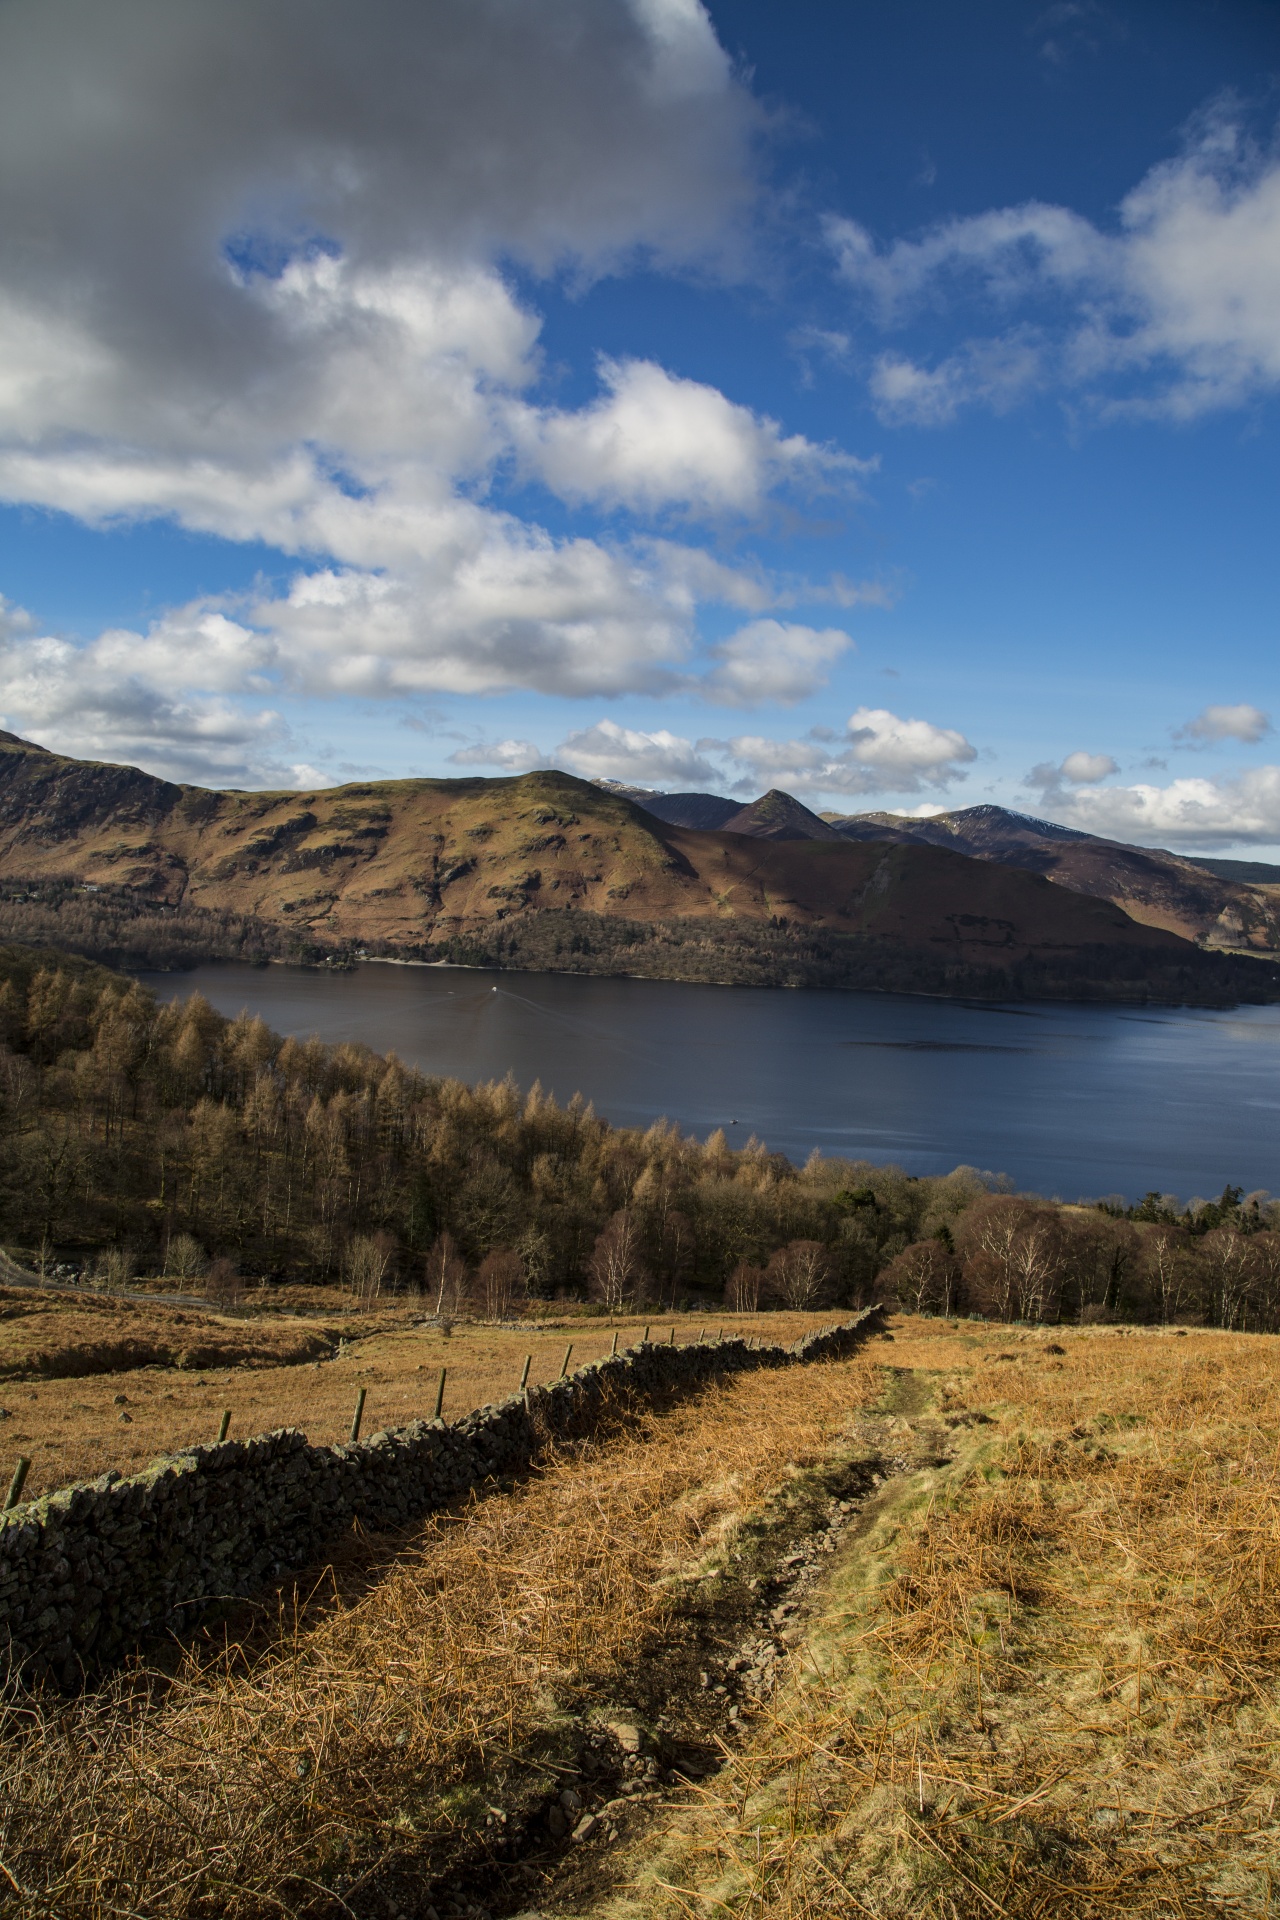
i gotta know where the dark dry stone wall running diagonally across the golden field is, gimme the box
[0,1308,879,1686]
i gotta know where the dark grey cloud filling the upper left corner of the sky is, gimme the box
[0,0,756,399]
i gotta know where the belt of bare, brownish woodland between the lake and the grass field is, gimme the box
[0,945,1280,1331]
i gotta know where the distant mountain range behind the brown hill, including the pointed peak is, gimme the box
[614,787,1280,952]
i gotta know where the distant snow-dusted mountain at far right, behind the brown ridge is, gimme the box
[825,806,1280,952]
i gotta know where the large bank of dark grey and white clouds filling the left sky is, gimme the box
[0,0,862,778]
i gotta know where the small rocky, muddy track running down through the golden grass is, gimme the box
[412,1367,948,1920]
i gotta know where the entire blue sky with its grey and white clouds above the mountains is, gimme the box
[0,0,1280,858]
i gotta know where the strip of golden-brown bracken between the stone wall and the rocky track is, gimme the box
[0,1359,877,1920]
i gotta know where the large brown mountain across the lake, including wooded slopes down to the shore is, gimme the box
[0,735,1280,1004]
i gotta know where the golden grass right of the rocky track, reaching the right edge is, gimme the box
[625,1321,1280,1920]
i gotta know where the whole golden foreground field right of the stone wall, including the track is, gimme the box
[0,1315,1280,1920]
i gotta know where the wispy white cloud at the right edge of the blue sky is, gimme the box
[827,106,1280,424]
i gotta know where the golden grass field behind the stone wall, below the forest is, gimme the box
[0,1288,833,1500]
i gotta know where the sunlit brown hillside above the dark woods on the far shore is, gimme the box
[0,735,1197,958]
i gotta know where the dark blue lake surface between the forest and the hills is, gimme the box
[142,964,1280,1200]
